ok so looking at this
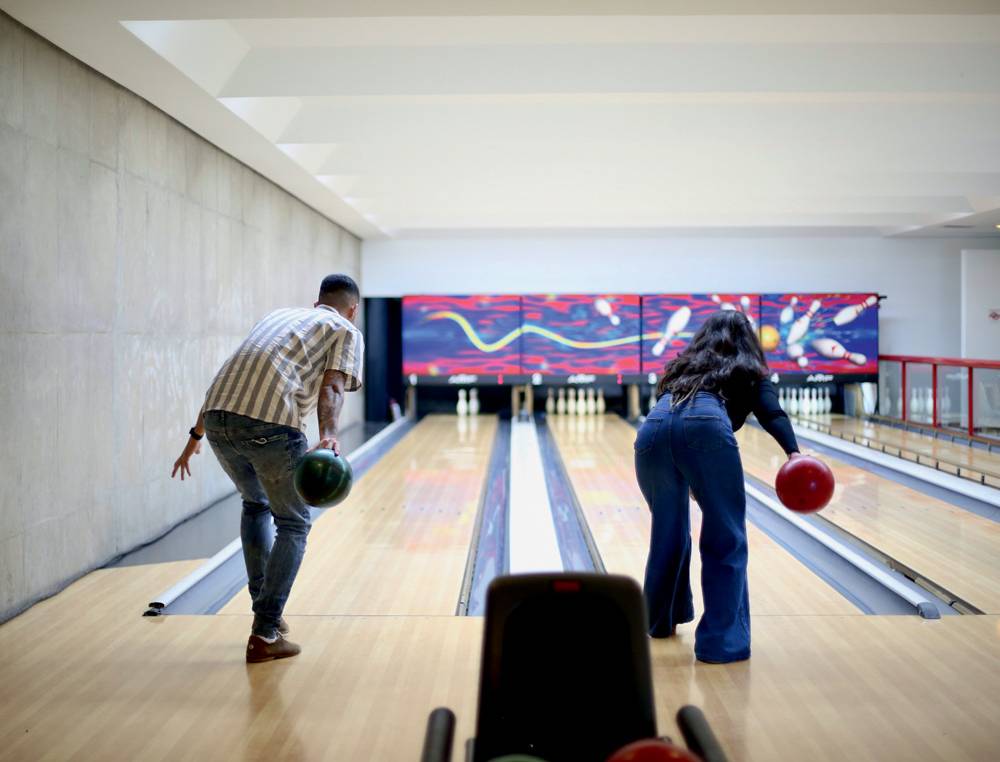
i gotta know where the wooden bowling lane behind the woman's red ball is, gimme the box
[736,426,1000,614]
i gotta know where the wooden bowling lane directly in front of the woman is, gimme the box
[549,416,862,616]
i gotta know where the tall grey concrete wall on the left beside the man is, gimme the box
[0,13,363,620]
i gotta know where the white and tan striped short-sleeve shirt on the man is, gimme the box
[204,305,365,428]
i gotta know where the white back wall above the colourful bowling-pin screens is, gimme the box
[362,235,1000,357]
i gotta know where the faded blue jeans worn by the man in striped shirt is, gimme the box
[205,410,312,638]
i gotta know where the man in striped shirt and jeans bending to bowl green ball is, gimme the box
[171,275,364,662]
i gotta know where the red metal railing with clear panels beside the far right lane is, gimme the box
[879,355,1000,439]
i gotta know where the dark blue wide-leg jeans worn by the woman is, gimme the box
[635,392,750,662]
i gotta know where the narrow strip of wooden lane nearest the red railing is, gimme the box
[796,415,1000,487]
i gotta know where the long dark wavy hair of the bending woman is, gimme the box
[656,310,767,404]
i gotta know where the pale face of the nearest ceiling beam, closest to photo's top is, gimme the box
[216,43,1000,97]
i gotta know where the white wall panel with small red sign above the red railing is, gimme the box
[962,250,1000,360]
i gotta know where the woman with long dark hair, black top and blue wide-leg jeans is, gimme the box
[635,311,798,663]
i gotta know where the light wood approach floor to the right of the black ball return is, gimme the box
[652,616,1000,762]
